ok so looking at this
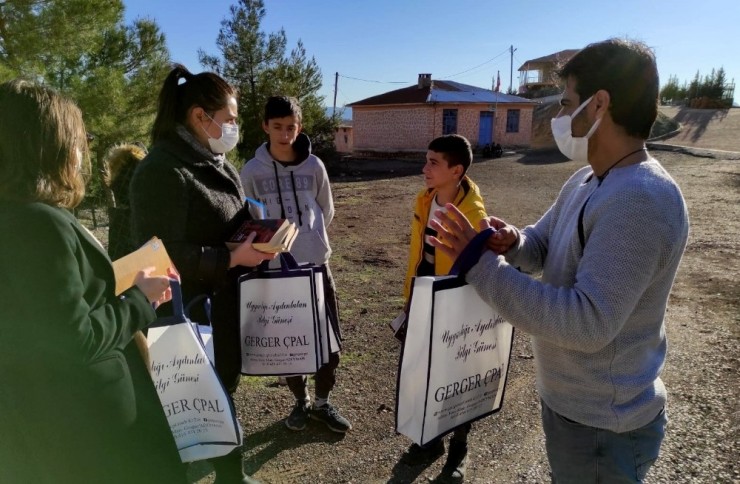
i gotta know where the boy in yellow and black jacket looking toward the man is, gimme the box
[402,134,486,481]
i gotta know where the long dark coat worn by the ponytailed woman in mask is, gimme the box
[130,133,249,391]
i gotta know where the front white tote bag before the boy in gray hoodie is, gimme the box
[239,253,322,376]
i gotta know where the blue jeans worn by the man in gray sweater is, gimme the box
[541,401,668,484]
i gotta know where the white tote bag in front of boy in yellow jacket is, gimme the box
[396,232,514,445]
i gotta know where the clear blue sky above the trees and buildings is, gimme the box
[123,0,740,106]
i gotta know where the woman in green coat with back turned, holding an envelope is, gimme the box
[0,80,186,483]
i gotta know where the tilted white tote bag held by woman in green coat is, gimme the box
[147,281,242,462]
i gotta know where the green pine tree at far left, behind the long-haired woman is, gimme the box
[0,0,169,212]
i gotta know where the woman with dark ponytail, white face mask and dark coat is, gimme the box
[130,64,275,483]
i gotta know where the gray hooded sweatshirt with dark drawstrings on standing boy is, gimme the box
[240,133,334,264]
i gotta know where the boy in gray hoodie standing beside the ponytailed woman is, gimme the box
[241,96,352,433]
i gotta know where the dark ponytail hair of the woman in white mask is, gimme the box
[152,64,236,143]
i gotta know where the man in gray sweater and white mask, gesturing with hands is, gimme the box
[434,39,689,483]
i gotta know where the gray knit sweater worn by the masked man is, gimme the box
[467,159,689,432]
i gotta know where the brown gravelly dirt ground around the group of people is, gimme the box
[176,147,740,483]
